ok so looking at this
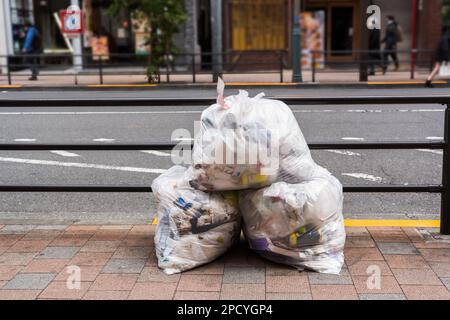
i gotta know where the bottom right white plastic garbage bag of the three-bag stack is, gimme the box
[239,167,345,274]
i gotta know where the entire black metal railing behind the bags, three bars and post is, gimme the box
[0,95,450,234]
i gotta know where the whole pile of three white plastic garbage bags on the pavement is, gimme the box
[152,81,345,274]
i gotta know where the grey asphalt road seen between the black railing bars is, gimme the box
[0,88,448,223]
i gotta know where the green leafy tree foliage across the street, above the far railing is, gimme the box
[109,0,187,82]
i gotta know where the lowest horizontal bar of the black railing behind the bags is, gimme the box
[0,185,444,193]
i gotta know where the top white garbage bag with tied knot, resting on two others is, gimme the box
[191,84,316,191]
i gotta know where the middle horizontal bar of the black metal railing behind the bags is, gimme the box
[0,141,446,151]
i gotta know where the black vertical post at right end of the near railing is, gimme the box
[441,103,450,235]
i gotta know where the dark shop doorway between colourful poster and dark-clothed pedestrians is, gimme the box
[331,7,353,56]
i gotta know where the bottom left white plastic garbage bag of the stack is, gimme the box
[152,166,241,274]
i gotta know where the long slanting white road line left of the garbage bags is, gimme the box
[0,157,166,173]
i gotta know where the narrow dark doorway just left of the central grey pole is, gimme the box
[197,0,212,70]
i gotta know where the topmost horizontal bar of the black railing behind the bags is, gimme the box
[0,94,450,107]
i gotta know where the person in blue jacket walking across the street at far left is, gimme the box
[22,22,42,81]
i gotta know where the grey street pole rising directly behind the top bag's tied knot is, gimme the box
[211,0,222,82]
